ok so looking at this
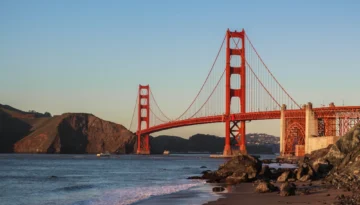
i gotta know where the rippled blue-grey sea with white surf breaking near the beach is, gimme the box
[0,154,275,205]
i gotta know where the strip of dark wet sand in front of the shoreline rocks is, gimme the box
[204,181,351,205]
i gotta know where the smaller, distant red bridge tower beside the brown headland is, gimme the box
[136,85,150,154]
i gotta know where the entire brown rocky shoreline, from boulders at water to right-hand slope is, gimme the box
[189,124,360,205]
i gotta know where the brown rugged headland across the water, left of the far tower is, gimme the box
[0,106,136,154]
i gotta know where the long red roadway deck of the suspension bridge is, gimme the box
[136,106,360,134]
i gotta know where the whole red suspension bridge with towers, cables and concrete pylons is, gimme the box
[130,30,360,156]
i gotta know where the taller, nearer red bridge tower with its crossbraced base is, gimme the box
[223,29,246,156]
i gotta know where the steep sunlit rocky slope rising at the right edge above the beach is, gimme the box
[308,124,360,204]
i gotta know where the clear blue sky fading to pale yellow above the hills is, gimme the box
[0,0,360,138]
